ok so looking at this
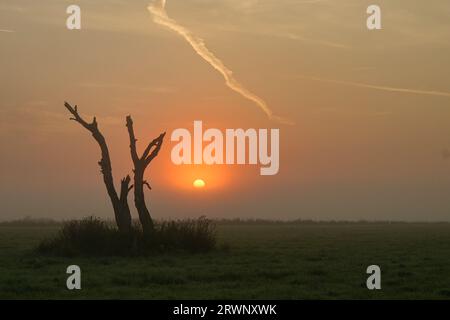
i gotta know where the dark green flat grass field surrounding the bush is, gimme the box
[0,223,450,299]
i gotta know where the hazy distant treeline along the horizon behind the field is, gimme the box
[0,217,449,227]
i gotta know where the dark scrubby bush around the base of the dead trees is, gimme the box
[37,217,216,256]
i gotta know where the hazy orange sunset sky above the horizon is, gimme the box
[0,0,450,221]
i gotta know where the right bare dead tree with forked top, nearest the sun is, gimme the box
[126,116,166,234]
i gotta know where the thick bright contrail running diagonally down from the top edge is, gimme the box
[147,0,293,124]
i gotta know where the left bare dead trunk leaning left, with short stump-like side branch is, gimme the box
[64,102,133,232]
